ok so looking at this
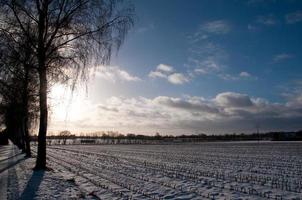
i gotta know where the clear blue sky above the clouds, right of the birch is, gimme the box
[109,0,302,101]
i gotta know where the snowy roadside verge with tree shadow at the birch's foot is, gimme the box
[0,144,82,200]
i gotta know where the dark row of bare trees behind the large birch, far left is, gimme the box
[0,23,38,157]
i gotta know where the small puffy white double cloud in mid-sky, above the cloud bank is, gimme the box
[148,64,190,85]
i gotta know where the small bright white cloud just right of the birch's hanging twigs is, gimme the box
[96,66,141,82]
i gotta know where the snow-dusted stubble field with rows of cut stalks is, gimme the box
[42,142,302,199]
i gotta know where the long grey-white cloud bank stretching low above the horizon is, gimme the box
[51,92,302,134]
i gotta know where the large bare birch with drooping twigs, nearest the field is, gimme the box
[0,0,133,169]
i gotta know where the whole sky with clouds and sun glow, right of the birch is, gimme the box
[50,0,302,134]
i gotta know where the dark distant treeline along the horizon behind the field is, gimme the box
[32,130,302,145]
